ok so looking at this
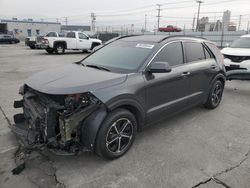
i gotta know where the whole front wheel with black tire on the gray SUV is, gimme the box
[95,109,137,160]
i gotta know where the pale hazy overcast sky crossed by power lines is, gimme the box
[0,0,250,29]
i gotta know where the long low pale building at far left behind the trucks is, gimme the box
[0,18,61,40]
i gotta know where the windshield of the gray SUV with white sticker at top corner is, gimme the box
[82,41,154,73]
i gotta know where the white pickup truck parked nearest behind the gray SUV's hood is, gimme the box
[41,31,102,54]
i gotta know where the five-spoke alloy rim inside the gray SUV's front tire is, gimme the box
[106,118,133,154]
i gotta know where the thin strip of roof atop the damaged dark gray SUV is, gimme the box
[119,35,207,43]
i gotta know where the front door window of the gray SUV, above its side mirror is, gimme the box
[153,42,183,66]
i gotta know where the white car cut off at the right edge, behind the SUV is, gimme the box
[221,35,250,71]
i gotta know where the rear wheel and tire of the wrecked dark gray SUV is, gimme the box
[204,80,224,109]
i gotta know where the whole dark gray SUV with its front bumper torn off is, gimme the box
[12,36,225,159]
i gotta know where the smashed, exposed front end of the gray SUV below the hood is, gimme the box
[12,85,103,154]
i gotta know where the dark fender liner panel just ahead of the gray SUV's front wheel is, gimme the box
[81,104,108,151]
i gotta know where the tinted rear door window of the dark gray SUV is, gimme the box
[184,42,206,63]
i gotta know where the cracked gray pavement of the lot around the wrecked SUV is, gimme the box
[0,43,250,188]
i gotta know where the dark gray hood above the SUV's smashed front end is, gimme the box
[25,64,127,95]
